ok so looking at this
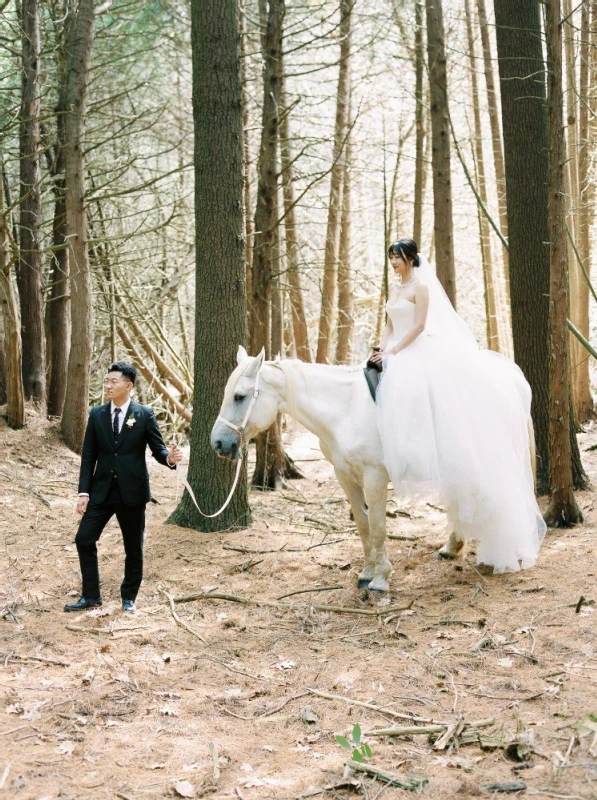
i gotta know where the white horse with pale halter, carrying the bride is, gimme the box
[211,347,472,591]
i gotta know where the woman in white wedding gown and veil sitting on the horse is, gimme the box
[372,239,546,573]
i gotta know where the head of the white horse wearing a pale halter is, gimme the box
[211,347,280,461]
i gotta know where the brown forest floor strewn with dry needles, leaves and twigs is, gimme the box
[0,413,597,800]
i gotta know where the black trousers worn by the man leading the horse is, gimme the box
[75,478,146,600]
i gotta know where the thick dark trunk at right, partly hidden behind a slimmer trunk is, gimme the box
[494,0,586,494]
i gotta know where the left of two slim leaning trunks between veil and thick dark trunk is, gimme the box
[464,0,500,352]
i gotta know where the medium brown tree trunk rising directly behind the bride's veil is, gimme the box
[426,0,456,308]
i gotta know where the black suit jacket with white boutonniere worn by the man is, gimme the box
[79,400,174,506]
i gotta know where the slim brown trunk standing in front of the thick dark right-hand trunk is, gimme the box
[545,0,583,528]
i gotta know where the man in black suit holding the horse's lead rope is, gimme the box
[64,361,182,611]
